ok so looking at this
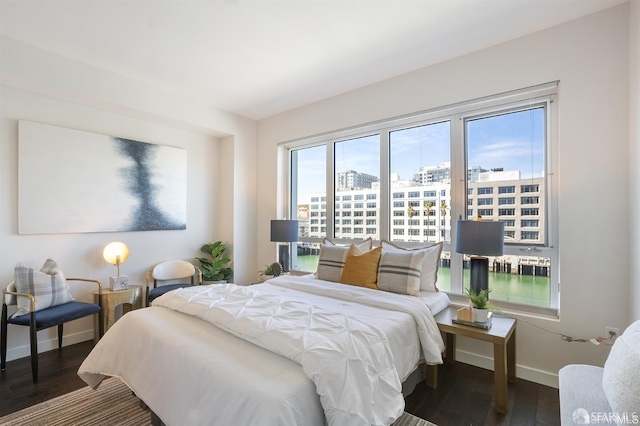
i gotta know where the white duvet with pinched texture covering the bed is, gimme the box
[79,277,444,425]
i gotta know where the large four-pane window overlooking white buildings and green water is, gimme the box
[283,83,559,313]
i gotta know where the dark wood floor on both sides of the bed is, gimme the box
[0,342,560,426]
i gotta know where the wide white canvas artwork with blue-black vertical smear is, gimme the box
[18,120,187,234]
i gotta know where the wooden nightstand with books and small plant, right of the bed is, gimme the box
[435,306,516,414]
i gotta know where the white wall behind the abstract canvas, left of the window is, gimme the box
[0,37,256,359]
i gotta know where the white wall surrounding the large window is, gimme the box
[257,4,638,385]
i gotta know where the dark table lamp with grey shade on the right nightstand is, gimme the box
[456,220,504,294]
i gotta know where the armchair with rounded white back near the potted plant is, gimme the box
[147,260,202,306]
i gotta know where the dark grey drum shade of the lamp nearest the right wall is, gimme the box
[456,220,504,256]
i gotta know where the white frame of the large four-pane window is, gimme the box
[279,81,560,316]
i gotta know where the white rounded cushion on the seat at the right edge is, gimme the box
[602,320,640,416]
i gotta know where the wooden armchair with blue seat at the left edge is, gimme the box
[0,278,104,383]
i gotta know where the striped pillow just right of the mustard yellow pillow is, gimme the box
[378,250,427,296]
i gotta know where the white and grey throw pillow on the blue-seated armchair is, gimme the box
[14,259,75,316]
